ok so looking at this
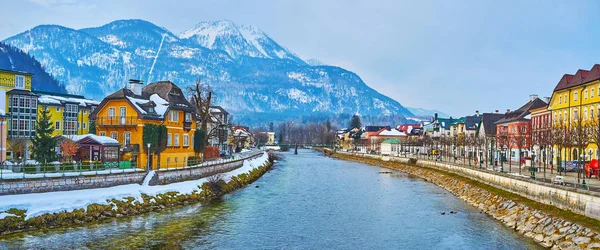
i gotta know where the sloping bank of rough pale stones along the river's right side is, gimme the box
[334,154,600,249]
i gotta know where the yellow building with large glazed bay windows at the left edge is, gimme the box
[0,69,38,159]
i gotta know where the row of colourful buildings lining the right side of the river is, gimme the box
[336,64,600,172]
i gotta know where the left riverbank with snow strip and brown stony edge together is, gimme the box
[0,153,273,235]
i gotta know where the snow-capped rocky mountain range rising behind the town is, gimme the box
[4,20,412,122]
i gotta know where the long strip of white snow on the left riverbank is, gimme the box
[0,152,269,219]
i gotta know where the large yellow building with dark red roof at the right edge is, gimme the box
[548,64,600,162]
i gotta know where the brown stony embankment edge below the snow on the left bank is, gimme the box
[0,154,273,235]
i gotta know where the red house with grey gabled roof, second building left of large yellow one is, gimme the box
[495,95,547,162]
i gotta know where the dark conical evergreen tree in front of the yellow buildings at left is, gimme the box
[31,106,56,163]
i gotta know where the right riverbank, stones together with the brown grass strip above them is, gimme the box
[329,153,600,249]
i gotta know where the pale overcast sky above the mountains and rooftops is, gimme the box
[0,0,600,116]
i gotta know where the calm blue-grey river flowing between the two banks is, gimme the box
[0,150,538,249]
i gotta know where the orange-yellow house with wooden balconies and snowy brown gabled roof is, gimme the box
[90,80,196,169]
